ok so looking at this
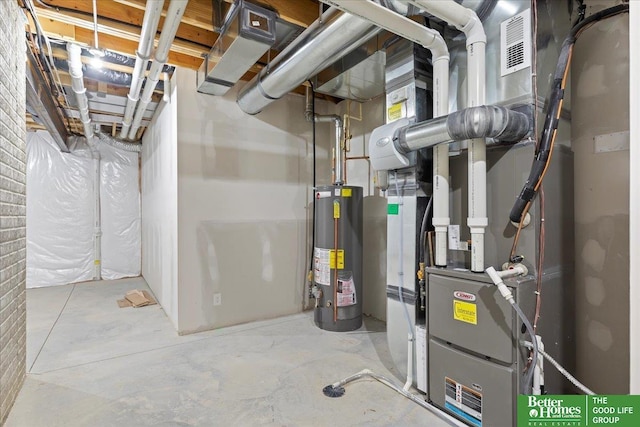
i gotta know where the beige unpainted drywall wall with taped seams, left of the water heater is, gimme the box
[176,69,329,333]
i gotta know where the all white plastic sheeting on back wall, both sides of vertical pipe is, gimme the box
[27,131,140,288]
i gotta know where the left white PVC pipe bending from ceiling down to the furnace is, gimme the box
[322,0,450,266]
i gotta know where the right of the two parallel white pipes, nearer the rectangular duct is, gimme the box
[129,0,189,139]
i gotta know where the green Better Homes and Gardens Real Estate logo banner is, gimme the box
[518,395,640,427]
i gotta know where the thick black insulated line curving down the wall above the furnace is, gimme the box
[509,4,629,223]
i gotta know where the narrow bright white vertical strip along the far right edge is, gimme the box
[629,1,640,394]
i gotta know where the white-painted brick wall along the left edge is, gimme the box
[0,0,26,425]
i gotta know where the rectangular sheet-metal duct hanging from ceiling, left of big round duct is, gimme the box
[197,0,277,95]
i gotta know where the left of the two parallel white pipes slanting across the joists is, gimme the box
[120,0,164,138]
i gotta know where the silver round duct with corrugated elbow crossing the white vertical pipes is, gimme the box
[393,105,530,154]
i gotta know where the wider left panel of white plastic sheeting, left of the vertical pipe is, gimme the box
[27,131,93,288]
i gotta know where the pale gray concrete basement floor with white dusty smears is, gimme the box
[6,278,456,427]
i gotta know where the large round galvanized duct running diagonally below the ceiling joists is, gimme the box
[238,8,381,114]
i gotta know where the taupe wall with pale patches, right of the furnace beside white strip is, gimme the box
[571,7,633,394]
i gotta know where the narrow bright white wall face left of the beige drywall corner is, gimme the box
[141,84,178,329]
